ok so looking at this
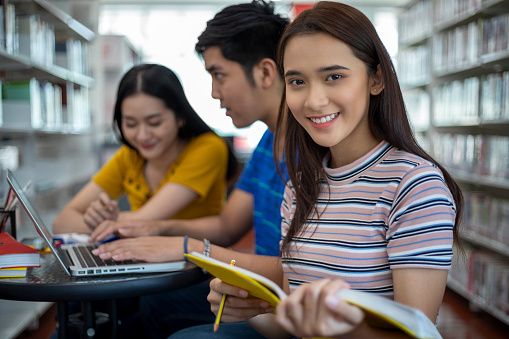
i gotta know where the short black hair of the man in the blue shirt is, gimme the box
[195,0,288,84]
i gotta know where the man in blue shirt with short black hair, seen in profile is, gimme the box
[90,0,288,338]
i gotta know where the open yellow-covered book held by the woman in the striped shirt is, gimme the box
[185,252,442,339]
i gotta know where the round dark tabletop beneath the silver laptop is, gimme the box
[0,254,207,301]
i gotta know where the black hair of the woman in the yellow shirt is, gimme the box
[113,64,238,179]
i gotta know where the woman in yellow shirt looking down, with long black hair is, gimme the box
[53,64,236,233]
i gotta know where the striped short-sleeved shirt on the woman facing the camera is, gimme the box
[281,142,456,297]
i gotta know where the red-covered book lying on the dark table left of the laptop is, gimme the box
[0,232,41,268]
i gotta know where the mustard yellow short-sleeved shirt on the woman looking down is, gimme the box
[92,132,228,219]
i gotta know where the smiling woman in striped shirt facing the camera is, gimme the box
[266,1,462,337]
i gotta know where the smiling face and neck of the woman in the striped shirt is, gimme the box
[284,33,383,167]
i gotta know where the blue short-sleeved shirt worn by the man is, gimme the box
[237,130,288,256]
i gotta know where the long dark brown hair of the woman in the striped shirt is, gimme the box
[274,1,463,254]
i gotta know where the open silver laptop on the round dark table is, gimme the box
[7,171,185,276]
